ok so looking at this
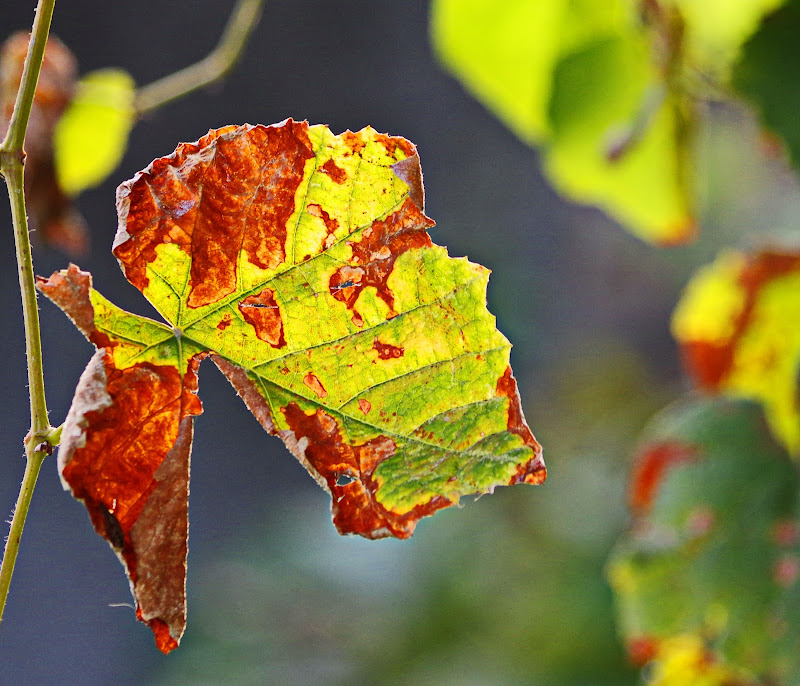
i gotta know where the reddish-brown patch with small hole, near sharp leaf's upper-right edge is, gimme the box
[329,198,434,326]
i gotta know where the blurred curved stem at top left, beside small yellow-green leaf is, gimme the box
[134,0,263,115]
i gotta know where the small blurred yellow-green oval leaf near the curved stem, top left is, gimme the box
[53,69,136,195]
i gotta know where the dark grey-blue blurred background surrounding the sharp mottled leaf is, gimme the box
[0,0,800,686]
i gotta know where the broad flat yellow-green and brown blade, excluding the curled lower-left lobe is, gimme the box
[115,120,545,537]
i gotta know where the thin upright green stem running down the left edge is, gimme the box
[0,0,55,621]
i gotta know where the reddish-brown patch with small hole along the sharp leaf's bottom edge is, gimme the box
[281,403,452,538]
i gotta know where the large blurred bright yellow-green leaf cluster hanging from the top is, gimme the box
[431,0,800,244]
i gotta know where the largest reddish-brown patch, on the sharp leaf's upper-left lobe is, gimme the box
[114,119,314,307]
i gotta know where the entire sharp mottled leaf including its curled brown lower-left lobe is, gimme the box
[39,120,546,652]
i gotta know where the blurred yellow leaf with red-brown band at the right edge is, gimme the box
[672,252,800,454]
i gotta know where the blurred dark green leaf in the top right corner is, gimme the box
[733,0,800,166]
